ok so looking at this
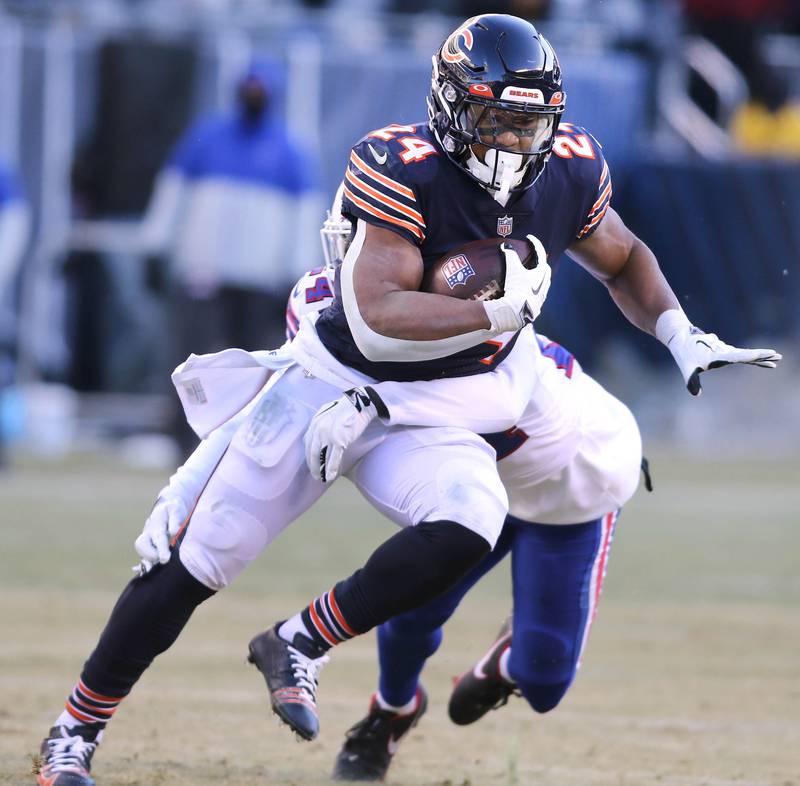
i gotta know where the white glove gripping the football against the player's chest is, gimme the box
[483,235,551,335]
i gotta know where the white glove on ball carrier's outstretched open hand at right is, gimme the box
[656,309,783,396]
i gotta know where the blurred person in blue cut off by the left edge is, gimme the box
[0,161,30,464]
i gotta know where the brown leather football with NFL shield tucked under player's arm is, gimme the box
[420,237,535,300]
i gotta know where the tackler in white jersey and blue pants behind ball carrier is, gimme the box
[159,230,649,781]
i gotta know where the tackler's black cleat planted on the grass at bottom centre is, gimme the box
[332,685,428,781]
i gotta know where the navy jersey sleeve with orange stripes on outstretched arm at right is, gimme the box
[559,123,612,240]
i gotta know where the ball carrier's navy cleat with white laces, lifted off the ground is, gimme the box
[247,623,329,740]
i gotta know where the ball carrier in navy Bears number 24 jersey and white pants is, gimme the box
[38,15,779,786]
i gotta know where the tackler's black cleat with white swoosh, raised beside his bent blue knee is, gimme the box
[447,617,520,726]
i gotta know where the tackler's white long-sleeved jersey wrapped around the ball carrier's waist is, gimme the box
[169,268,641,544]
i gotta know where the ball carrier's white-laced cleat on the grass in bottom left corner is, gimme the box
[33,726,101,786]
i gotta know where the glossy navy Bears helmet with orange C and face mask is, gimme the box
[428,14,565,198]
